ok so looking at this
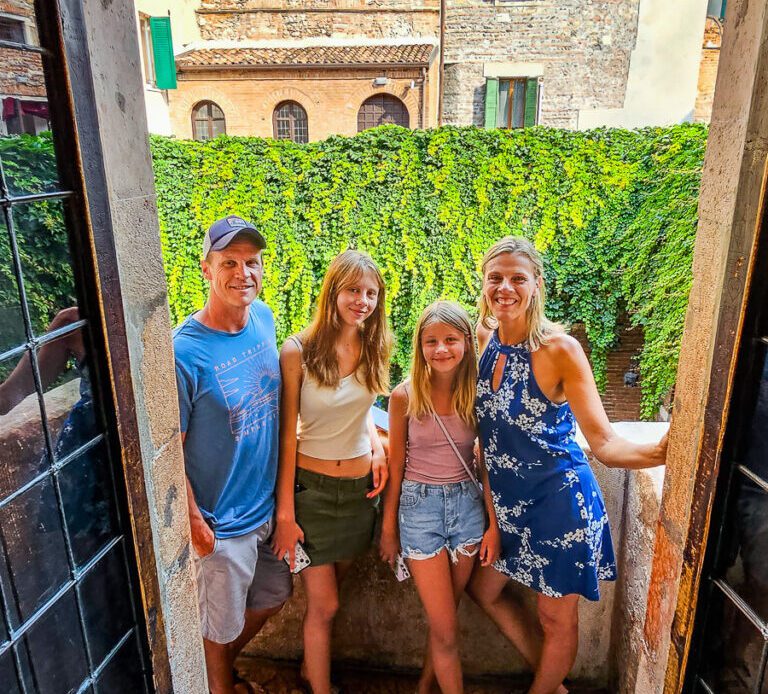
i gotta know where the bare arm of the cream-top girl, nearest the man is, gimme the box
[272,340,304,570]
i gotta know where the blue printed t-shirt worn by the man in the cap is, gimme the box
[173,300,280,538]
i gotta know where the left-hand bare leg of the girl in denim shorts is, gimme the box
[408,550,464,694]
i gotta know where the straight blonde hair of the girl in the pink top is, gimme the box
[407,301,477,427]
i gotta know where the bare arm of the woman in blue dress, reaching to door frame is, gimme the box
[548,335,667,470]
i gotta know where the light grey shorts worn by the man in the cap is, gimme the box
[194,520,293,643]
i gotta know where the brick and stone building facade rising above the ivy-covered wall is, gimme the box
[156,0,716,139]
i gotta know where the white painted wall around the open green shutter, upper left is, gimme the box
[134,0,200,135]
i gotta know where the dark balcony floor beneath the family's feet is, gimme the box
[237,657,607,694]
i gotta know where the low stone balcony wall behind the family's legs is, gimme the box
[246,422,667,691]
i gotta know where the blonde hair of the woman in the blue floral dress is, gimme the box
[478,236,563,352]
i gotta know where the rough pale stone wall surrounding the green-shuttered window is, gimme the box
[443,0,640,128]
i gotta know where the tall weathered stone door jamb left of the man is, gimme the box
[83,0,206,693]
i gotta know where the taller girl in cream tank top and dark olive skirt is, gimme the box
[273,251,390,694]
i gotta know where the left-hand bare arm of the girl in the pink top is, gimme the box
[379,385,408,566]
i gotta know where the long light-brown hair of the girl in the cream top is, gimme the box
[301,251,392,394]
